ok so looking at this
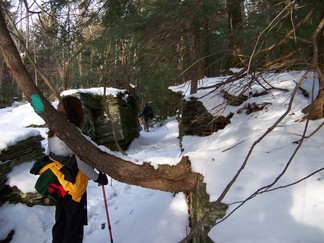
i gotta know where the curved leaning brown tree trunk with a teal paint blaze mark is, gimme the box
[0,9,200,192]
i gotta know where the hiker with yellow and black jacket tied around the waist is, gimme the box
[35,96,108,243]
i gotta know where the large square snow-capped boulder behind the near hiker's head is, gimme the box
[62,88,139,150]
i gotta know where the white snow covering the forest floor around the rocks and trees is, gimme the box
[0,69,324,243]
